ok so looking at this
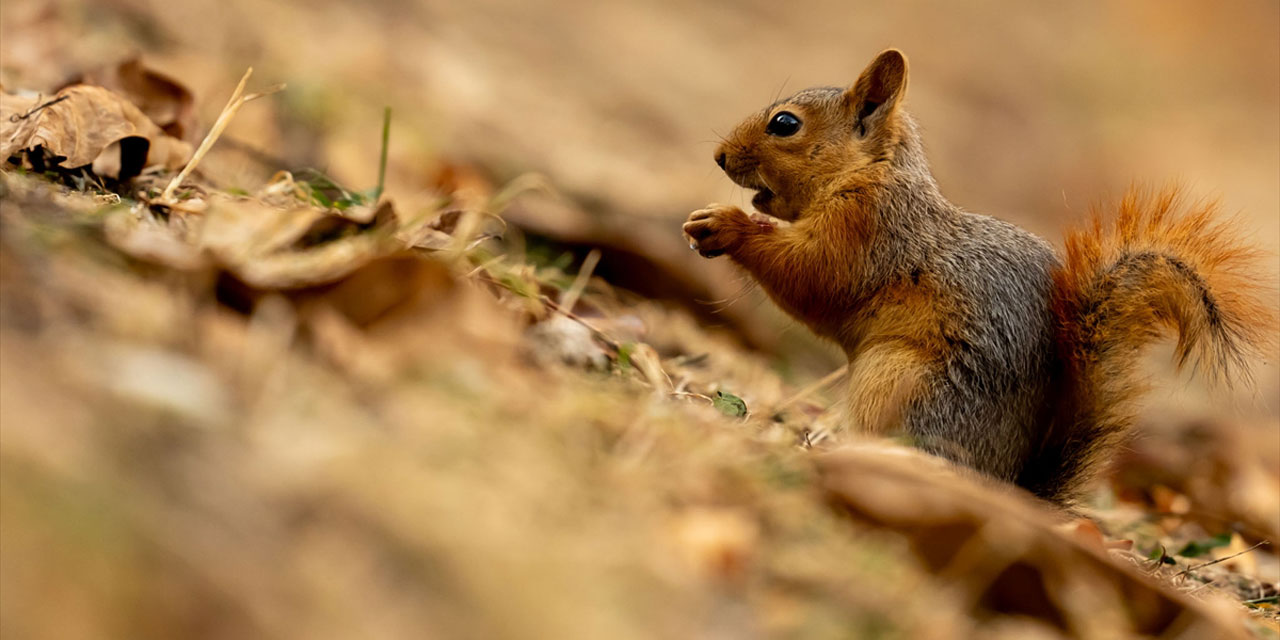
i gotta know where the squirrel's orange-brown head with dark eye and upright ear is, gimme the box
[716,49,906,220]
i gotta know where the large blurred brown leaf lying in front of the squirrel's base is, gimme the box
[819,445,1245,639]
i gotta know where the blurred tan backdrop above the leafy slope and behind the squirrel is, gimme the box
[3,0,1280,347]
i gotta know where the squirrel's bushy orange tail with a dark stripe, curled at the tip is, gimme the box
[1018,188,1275,503]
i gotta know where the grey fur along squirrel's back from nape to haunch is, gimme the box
[872,114,1059,480]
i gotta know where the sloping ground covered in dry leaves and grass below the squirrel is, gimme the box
[0,53,1276,639]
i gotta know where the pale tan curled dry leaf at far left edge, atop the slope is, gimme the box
[0,84,191,179]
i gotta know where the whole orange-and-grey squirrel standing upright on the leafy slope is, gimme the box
[684,49,1275,506]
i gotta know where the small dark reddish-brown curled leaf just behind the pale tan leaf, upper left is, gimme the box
[64,56,196,142]
